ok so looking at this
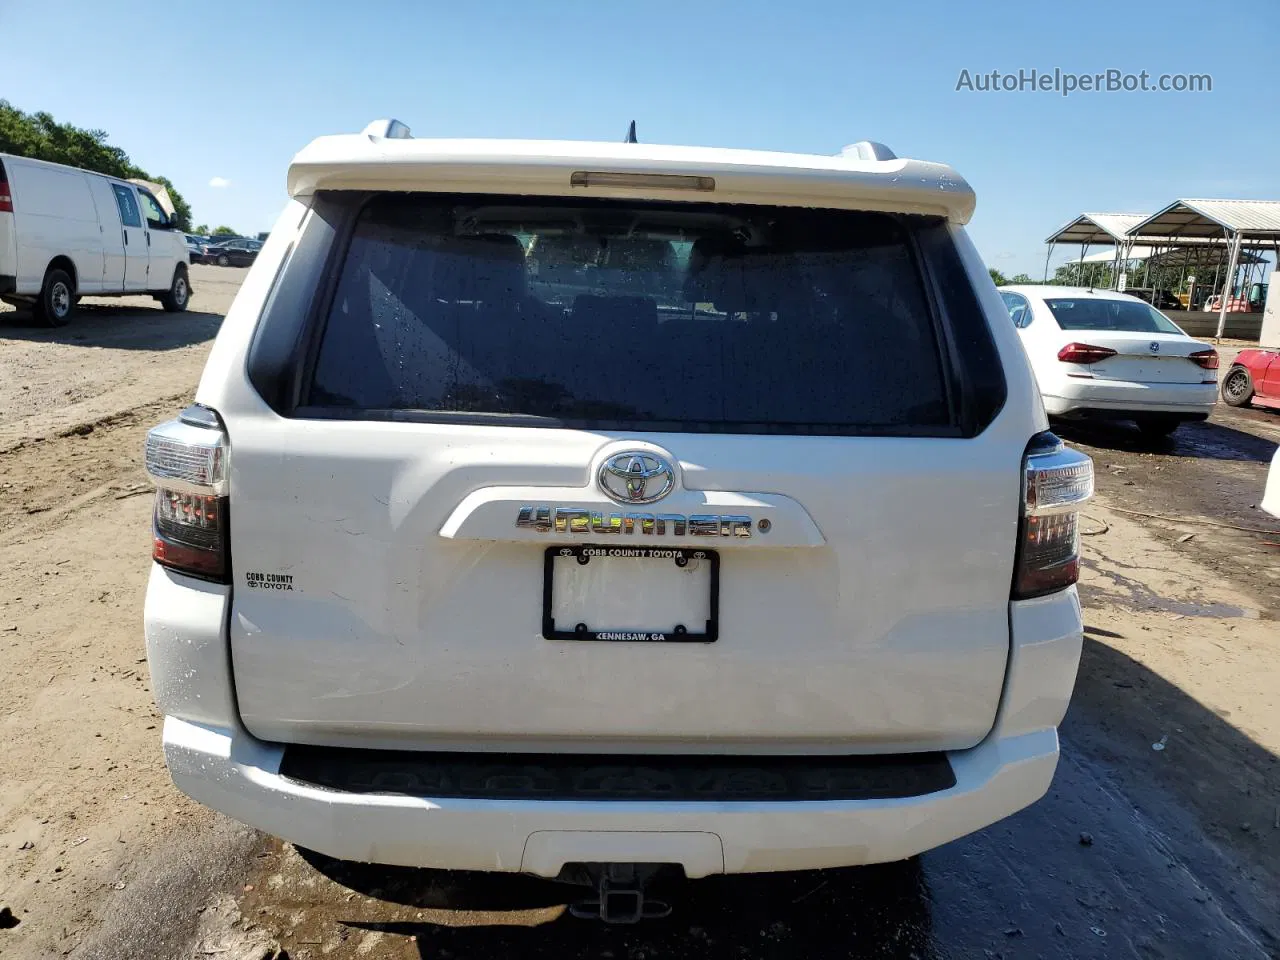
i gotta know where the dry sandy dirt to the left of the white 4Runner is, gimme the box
[0,266,244,956]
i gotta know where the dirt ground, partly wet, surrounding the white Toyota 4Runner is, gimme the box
[0,266,1280,960]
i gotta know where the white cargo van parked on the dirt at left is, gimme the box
[0,154,191,326]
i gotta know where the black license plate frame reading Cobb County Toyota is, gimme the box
[543,544,719,644]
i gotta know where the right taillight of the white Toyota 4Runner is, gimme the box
[1012,433,1093,600]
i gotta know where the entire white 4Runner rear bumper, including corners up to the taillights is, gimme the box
[146,547,1082,877]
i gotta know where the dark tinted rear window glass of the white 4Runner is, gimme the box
[301,193,955,433]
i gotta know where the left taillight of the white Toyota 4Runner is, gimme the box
[146,406,230,584]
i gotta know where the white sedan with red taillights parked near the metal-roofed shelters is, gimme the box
[1000,285,1217,436]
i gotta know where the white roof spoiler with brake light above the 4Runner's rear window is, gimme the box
[288,120,975,224]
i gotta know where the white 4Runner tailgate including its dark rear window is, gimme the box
[209,195,1033,751]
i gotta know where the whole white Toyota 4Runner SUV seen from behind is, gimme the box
[146,122,1093,919]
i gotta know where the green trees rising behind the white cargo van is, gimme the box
[0,100,191,230]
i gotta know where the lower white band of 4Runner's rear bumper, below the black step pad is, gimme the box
[164,717,1057,877]
